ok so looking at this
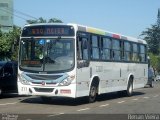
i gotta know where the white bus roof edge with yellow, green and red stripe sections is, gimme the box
[22,23,147,44]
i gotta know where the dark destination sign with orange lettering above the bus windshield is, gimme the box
[22,25,74,37]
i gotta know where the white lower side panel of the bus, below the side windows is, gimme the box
[77,61,148,97]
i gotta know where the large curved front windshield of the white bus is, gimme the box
[20,38,74,72]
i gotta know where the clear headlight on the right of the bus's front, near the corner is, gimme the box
[59,75,75,86]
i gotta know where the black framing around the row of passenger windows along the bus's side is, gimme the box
[77,31,147,64]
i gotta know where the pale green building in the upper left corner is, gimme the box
[0,0,13,32]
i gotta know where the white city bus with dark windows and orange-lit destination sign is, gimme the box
[18,23,148,102]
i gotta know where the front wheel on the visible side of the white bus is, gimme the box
[88,82,98,103]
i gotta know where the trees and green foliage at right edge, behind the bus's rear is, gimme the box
[141,9,160,72]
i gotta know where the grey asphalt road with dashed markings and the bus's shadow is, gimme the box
[0,82,160,120]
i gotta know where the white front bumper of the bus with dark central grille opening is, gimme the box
[18,82,76,98]
